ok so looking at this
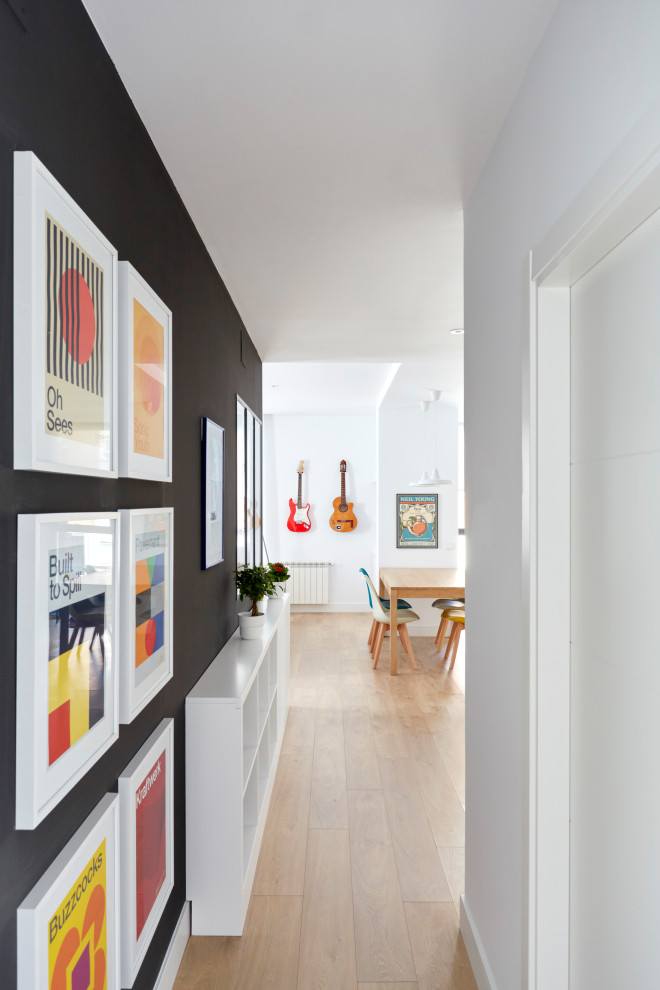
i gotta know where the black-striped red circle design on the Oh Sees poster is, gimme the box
[46,214,104,396]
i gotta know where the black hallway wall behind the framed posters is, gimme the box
[0,0,261,990]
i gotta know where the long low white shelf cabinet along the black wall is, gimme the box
[186,595,290,935]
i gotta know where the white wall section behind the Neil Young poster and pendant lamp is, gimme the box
[378,404,458,636]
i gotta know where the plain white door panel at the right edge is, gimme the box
[570,205,660,990]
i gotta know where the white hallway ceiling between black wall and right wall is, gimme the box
[84,0,557,372]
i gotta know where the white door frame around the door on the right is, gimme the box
[523,130,660,990]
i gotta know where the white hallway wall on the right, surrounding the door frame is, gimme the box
[465,0,660,990]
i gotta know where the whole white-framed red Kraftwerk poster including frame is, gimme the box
[119,718,174,988]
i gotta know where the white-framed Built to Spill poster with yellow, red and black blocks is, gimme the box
[16,512,119,829]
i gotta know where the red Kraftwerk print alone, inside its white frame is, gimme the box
[135,750,167,940]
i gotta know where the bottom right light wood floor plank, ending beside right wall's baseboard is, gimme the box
[405,903,477,990]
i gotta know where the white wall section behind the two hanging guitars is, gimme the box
[264,413,377,611]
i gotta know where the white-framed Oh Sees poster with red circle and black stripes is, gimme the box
[14,151,118,478]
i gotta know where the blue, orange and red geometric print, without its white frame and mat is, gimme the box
[135,529,167,685]
